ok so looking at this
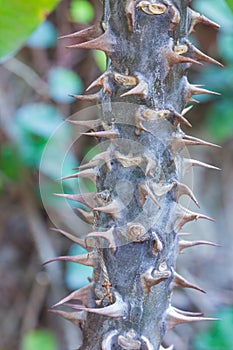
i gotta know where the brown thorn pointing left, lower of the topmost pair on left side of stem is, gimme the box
[67,31,115,54]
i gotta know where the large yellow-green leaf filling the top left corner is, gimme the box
[0,0,59,60]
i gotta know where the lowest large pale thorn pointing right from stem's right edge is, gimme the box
[166,306,218,330]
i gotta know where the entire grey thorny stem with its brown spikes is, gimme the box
[48,0,218,350]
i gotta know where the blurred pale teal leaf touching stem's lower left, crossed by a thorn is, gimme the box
[65,244,93,290]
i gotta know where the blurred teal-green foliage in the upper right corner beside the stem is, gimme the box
[194,0,233,142]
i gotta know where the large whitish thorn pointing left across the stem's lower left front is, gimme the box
[73,292,128,318]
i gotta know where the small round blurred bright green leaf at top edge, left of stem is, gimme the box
[70,0,95,24]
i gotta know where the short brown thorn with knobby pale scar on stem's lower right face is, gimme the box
[141,266,171,294]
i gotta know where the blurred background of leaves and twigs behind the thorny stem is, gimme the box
[0,0,233,350]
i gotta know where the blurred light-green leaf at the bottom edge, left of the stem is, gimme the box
[21,329,58,350]
